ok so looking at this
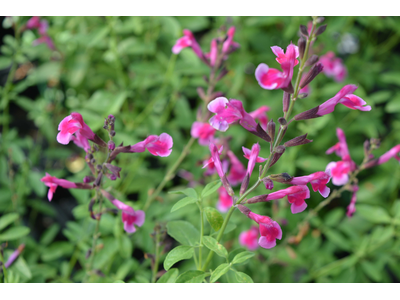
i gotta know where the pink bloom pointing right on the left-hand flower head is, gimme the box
[129,133,173,157]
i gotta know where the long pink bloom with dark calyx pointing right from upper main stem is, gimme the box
[294,84,371,121]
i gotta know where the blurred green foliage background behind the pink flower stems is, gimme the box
[0,17,400,282]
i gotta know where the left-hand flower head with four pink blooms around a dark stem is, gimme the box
[41,112,173,233]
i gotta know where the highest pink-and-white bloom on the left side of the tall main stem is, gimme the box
[255,44,299,90]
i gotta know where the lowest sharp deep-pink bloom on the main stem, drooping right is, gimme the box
[248,212,282,249]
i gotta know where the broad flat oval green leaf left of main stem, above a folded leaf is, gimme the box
[167,221,200,246]
